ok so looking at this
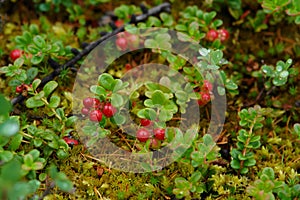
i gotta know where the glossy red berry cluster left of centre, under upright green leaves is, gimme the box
[81,97,117,122]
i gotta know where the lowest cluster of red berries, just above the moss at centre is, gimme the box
[136,119,165,148]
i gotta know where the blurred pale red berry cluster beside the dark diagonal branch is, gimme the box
[116,32,140,51]
